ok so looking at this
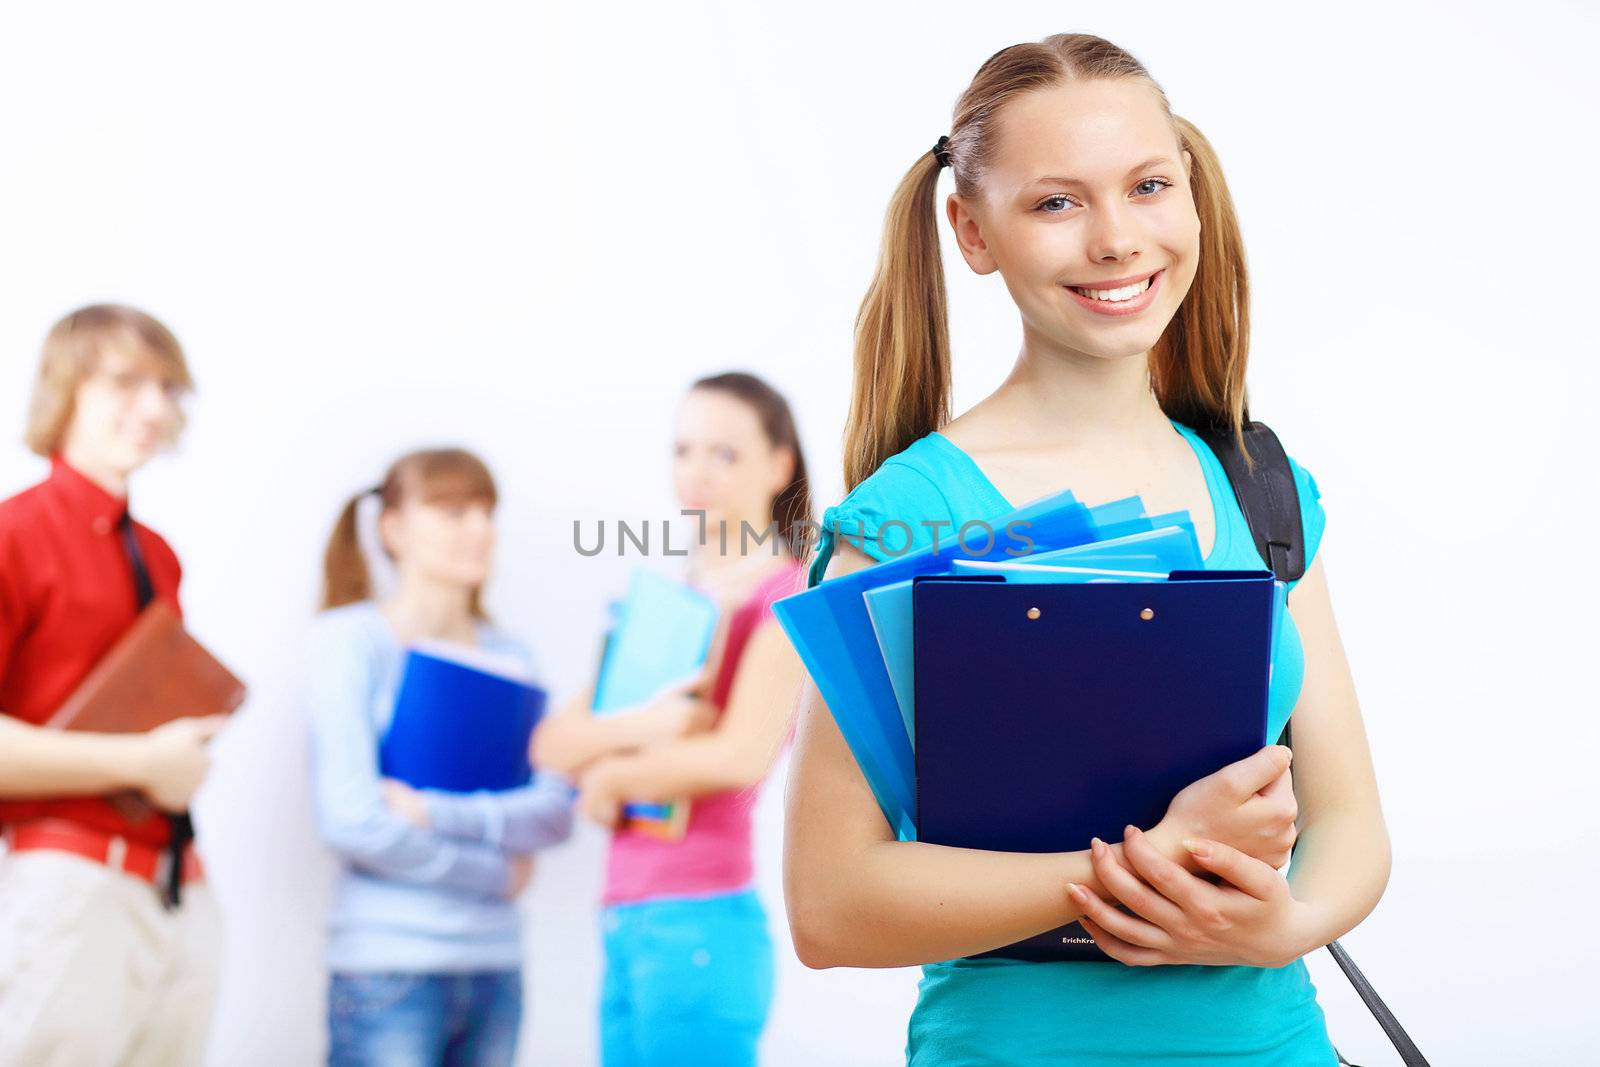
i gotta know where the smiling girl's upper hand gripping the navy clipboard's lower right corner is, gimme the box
[1150,745,1299,870]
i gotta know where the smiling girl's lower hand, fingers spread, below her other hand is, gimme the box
[1067,827,1315,968]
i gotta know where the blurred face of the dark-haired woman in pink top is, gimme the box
[672,389,794,545]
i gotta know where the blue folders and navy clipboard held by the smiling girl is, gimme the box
[774,493,1285,960]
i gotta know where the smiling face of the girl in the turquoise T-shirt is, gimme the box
[947,78,1200,358]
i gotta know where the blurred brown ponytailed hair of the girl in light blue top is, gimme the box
[322,448,499,619]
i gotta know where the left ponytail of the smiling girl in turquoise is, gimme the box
[843,152,950,491]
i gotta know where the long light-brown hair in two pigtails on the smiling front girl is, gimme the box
[843,34,1250,490]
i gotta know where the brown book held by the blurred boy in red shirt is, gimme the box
[46,600,245,734]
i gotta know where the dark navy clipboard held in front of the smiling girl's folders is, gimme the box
[912,571,1277,960]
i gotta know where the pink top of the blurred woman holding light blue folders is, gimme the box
[602,560,802,904]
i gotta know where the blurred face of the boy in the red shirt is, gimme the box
[62,346,184,475]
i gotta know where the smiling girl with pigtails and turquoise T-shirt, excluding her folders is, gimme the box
[786,34,1389,1067]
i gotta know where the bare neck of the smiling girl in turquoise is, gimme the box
[994,323,1166,445]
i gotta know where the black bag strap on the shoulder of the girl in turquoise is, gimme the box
[1195,421,1427,1067]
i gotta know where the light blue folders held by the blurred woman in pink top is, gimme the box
[594,569,718,841]
